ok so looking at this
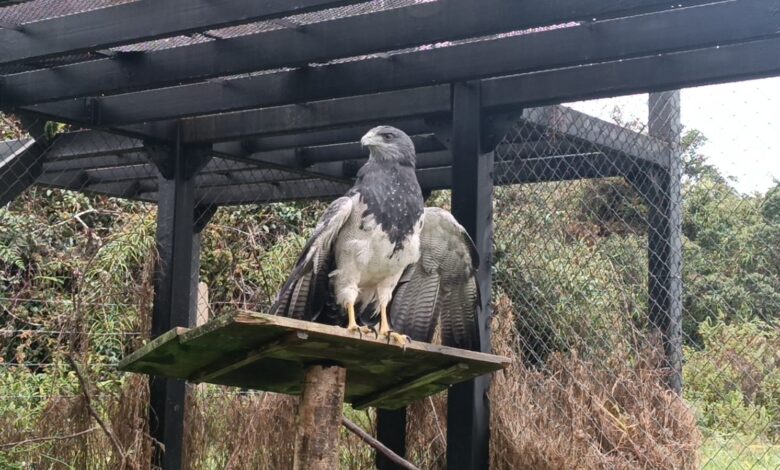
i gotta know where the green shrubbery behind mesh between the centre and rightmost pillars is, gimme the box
[493,180,647,365]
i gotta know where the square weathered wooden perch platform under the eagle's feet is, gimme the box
[119,312,509,409]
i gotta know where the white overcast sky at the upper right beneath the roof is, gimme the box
[569,78,780,192]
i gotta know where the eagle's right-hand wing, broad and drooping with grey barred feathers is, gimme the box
[390,207,480,349]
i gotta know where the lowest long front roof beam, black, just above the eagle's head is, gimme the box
[175,35,780,142]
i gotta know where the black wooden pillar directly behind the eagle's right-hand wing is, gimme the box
[447,81,493,470]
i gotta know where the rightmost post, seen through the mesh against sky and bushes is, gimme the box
[638,91,682,393]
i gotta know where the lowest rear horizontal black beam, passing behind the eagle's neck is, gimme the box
[36,149,646,205]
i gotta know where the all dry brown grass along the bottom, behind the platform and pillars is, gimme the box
[0,298,701,470]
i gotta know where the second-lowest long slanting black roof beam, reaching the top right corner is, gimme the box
[25,0,780,126]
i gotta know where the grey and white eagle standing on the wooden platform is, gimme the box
[270,126,480,349]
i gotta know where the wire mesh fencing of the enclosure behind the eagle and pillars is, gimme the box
[0,80,780,468]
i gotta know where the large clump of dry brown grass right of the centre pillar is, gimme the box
[490,298,701,469]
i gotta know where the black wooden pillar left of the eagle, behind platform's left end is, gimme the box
[149,133,210,470]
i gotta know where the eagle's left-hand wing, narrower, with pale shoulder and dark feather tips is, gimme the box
[270,196,352,321]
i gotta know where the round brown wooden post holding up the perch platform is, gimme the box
[293,365,347,470]
